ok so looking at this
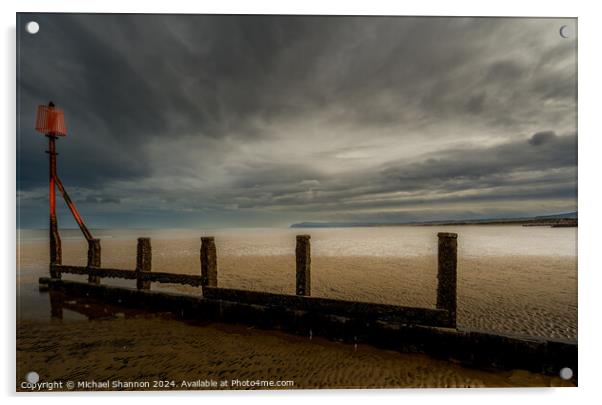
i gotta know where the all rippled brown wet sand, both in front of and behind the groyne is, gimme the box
[17,239,577,388]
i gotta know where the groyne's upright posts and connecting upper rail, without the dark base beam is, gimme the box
[50,233,457,328]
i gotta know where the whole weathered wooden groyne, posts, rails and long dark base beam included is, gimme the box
[40,233,577,378]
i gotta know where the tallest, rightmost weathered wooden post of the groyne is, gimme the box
[437,232,458,328]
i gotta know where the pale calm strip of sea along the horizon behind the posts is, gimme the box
[18,225,577,257]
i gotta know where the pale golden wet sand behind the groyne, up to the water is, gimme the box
[16,240,577,340]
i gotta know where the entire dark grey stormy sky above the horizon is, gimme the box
[17,14,577,228]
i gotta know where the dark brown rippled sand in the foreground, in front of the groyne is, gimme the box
[17,317,573,389]
